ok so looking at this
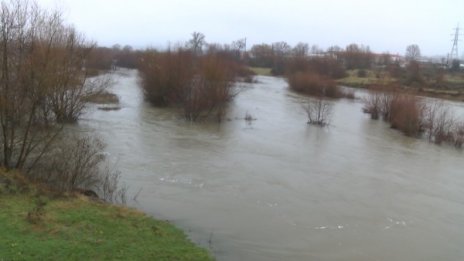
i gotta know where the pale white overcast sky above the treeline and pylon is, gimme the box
[38,0,464,55]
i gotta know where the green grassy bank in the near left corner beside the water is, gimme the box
[0,190,212,260]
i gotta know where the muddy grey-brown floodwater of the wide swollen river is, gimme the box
[78,70,464,261]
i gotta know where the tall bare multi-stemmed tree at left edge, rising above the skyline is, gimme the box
[0,0,96,170]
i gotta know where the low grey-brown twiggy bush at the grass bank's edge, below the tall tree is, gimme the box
[32,137,126,203]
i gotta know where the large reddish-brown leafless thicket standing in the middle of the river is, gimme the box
[140,45,245,121]
